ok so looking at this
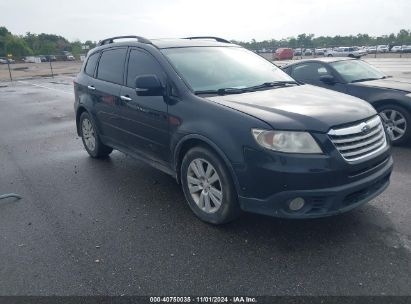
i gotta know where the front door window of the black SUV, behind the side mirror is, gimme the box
[126,49,164,88]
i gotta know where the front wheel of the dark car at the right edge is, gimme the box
[378,104,411,145]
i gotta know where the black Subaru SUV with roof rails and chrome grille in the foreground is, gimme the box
[74,36,393,224]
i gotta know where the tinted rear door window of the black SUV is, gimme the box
[97,48,127,84]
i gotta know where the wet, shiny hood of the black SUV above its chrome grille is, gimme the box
[207,85,376,133]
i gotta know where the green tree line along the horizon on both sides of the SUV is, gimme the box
[0,26,411,58]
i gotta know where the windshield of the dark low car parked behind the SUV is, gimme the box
[330,60,386,82]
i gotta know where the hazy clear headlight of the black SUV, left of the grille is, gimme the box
[251,129,322,154]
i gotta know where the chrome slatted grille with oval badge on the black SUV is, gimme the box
[328,116,387,161]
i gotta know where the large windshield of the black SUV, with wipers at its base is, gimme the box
[162,47,294,92]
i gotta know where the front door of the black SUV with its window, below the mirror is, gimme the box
[119,48,171,163]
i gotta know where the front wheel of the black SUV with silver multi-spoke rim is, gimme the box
[181,146,241,225]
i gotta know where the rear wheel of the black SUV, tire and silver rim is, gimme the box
[79,112,113,158]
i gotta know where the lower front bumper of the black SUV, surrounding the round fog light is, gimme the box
[239,155,393,218]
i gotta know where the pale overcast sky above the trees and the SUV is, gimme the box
[0,0,411,41]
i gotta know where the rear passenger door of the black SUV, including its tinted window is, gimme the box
[88,47,127,143]
